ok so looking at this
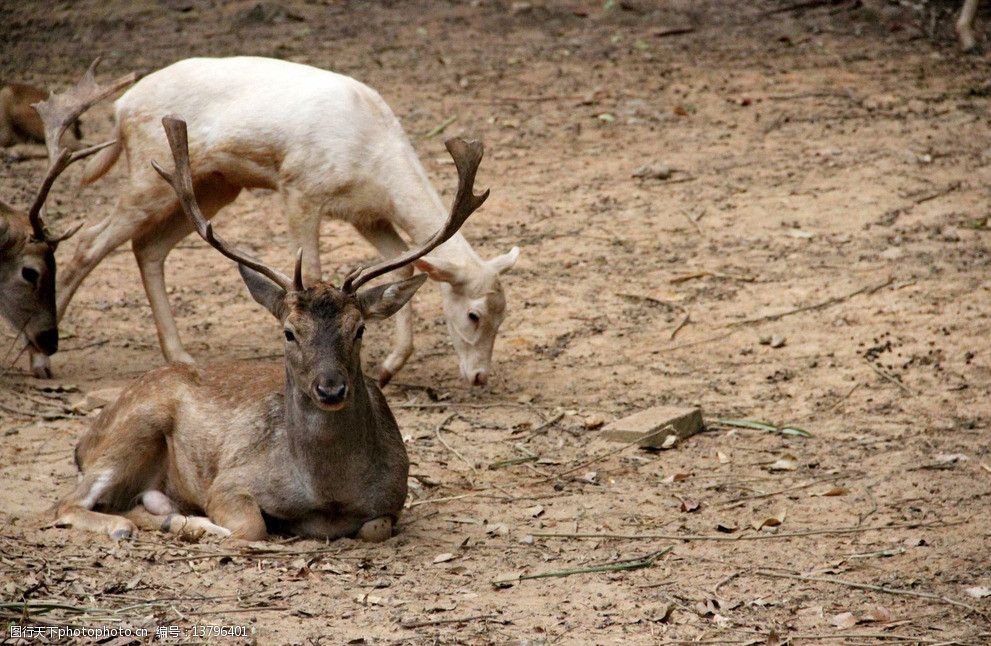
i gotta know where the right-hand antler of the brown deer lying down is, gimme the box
[341,138,489,294]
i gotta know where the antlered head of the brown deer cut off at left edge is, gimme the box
[0,60,134,376]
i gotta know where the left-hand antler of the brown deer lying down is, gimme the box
[151,115,303,291]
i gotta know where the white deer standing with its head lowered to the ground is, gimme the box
[45,57,519,385]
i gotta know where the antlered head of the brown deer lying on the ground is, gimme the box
[152,116,488,410]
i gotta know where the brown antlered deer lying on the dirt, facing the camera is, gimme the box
[56,117,488,541]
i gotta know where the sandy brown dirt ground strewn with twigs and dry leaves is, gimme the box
[0,0,991,644]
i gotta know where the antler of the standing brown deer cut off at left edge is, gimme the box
[28,58,137,246]
